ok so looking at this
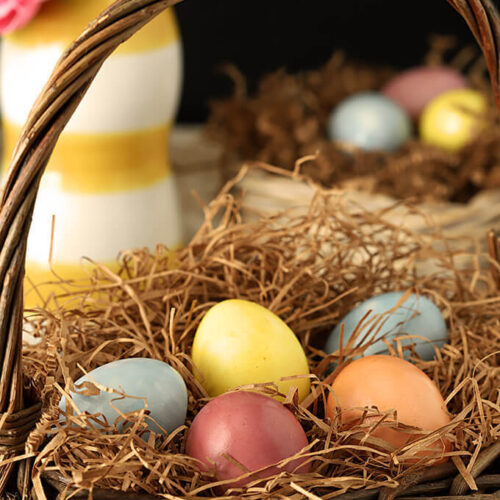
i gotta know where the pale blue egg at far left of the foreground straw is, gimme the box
[60,358,188,433]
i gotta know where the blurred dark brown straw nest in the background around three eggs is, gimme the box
[207,37,500,203]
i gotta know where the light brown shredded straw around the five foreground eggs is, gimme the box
[19,171,500,499]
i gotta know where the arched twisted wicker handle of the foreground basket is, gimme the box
[0,0,500,493]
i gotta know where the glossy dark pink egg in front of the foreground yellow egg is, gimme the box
[186,391,310,487]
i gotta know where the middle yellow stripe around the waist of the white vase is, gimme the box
[3,121,171,193]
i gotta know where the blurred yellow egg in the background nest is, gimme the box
[420,89,487,151]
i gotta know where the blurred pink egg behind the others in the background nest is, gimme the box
[381,66,468,119]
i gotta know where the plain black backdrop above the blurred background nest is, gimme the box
[176,0,499,122]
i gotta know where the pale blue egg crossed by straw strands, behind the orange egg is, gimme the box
[325,292,448,360]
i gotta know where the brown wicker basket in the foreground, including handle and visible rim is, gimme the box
[0,0,500,499]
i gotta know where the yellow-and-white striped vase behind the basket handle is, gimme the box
[0,0,182,307]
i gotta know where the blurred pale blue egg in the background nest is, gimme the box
[328,92,412,151]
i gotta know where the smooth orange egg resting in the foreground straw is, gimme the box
[327,355,451,463]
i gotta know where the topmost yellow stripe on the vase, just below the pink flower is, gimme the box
[8,0,179,54]
